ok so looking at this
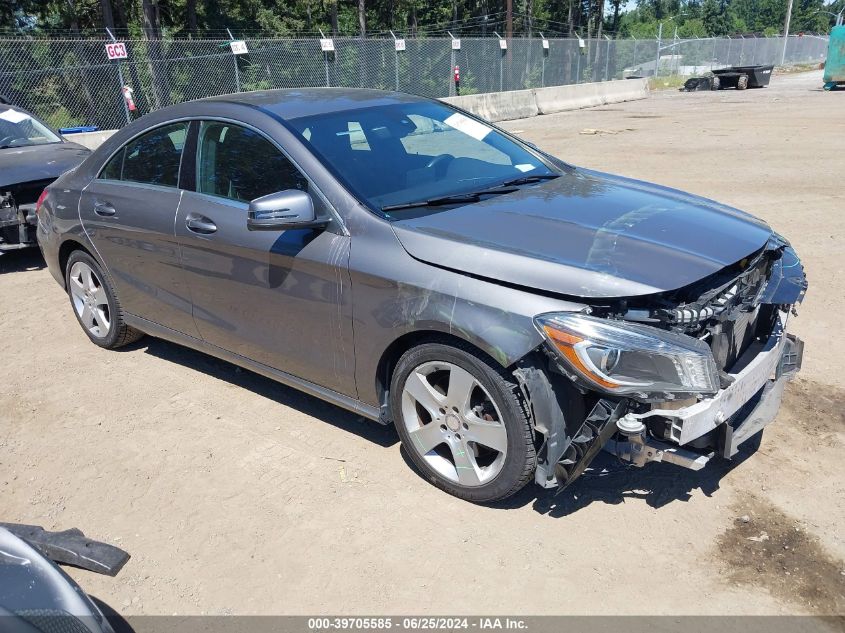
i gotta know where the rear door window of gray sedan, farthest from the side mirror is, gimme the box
[100,122,188,187]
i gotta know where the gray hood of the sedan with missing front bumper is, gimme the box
[393,169,772,298]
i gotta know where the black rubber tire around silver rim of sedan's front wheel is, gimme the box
[390,342,537,503]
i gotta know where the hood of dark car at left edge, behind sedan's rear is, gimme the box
[0,143,91,187]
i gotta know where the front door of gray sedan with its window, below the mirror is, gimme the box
[176,121,357,396]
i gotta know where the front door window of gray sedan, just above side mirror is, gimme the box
[197,121,308,202]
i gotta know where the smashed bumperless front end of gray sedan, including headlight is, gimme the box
[514,236,807,489]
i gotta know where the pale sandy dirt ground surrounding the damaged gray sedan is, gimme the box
[0,72,845,615]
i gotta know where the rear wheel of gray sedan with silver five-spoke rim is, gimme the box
[65,251,143,349]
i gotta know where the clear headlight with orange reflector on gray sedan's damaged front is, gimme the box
[535,313,719,394]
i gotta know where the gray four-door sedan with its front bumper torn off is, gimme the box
[37,88,806,502]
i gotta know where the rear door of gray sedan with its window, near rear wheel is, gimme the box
[79,122,198,337]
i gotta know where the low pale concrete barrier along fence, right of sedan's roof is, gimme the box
[441,79,648,121]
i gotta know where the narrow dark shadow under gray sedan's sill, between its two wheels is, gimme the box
[132,336,399,447]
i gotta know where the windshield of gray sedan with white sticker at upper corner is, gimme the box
[289,101,557,211]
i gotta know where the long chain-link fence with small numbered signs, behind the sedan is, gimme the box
[0,36,827,129]
